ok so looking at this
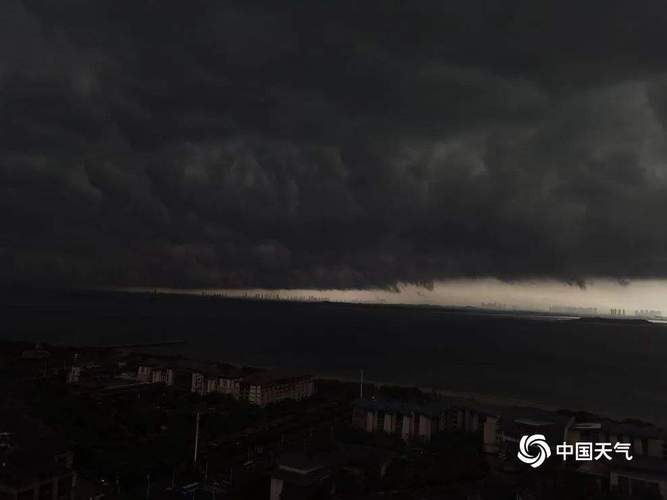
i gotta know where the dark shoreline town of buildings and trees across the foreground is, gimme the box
[0,342,667,500]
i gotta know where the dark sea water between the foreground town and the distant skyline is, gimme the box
[0,293,667,425]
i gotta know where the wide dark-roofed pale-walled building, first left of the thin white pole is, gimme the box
[239,370,315,406]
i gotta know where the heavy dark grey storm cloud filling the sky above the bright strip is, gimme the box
[0,0,667,287]
